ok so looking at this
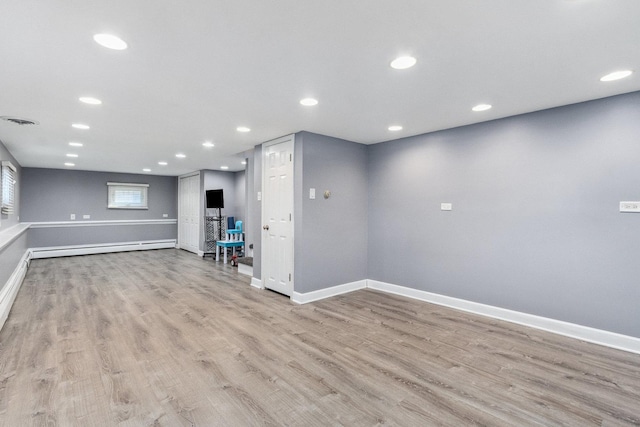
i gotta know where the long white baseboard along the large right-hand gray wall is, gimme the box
[367,280,640,354]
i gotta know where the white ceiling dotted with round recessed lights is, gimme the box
[0,0,640,175]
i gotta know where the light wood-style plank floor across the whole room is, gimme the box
[0,250,640,426]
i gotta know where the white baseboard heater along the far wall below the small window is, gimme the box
[29,239,176,259]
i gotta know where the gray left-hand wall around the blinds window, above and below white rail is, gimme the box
[0,141,28,289]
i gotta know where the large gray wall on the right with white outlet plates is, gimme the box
[368,92,640,337]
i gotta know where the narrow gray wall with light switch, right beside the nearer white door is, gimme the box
[294,132,367,293]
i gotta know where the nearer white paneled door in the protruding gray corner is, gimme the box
[262,135,294,296]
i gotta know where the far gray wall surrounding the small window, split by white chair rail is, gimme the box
[21,168,177,247]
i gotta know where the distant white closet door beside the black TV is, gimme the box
[178,174,200,253]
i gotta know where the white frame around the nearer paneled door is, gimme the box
[260,134,296,298]
